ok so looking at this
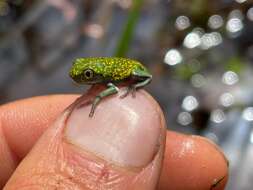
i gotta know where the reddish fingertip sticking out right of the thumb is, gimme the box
[159,132,228,190]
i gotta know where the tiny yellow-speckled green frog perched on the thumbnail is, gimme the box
[69,57,152,117]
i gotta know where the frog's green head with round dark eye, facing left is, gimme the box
[69,58,105,84]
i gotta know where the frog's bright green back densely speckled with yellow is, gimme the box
[85,57,146,81]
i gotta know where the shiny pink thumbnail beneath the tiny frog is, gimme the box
[65,92,162,167]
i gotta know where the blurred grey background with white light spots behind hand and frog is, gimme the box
[0,0,253,190]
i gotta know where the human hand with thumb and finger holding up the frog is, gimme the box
[0,89,228,190]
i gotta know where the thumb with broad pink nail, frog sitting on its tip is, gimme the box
[4,88,165,190]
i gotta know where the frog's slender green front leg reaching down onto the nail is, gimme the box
[89,83,119,117]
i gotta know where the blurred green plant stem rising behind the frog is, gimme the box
[115,0,143,57]
